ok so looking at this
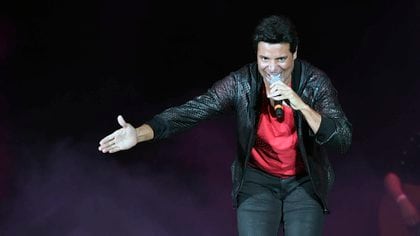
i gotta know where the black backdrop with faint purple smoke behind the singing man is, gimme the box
[0,0,420,236]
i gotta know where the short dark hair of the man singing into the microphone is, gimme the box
[253,15,299,53]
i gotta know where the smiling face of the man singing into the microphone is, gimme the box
[257,42,297,83]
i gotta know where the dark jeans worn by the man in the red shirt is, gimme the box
[237,167,324,236]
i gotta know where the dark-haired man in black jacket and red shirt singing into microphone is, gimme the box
[99,16,352,236]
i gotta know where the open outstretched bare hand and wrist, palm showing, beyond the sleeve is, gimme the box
[98,115,154,153]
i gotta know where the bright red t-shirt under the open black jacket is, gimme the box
[250,91,305,177]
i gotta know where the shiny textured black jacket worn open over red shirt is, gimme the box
[146,59,352,213]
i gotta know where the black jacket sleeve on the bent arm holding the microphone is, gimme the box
[313,75,353,153]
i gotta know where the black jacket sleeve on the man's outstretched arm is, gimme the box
[145,75,236,140]
